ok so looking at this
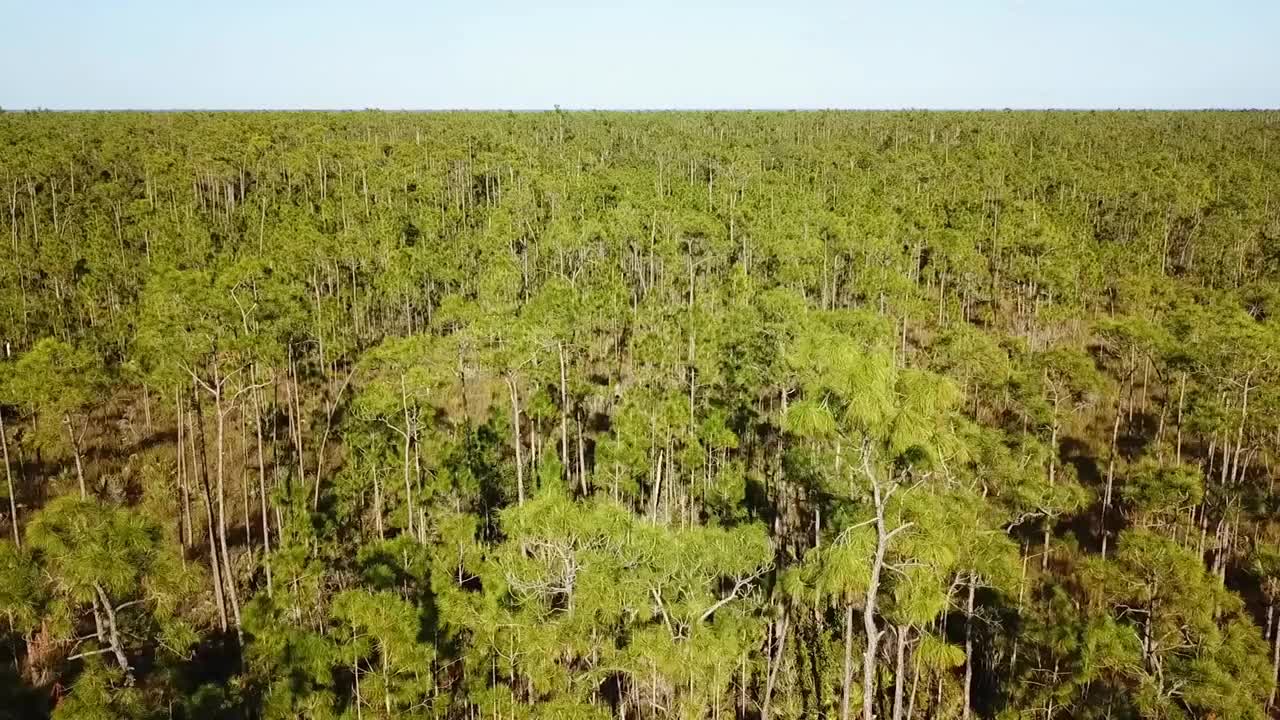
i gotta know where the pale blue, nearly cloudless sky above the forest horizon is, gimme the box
[0,0,1280,109]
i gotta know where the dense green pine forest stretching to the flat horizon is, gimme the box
[0,109,1280,720]
